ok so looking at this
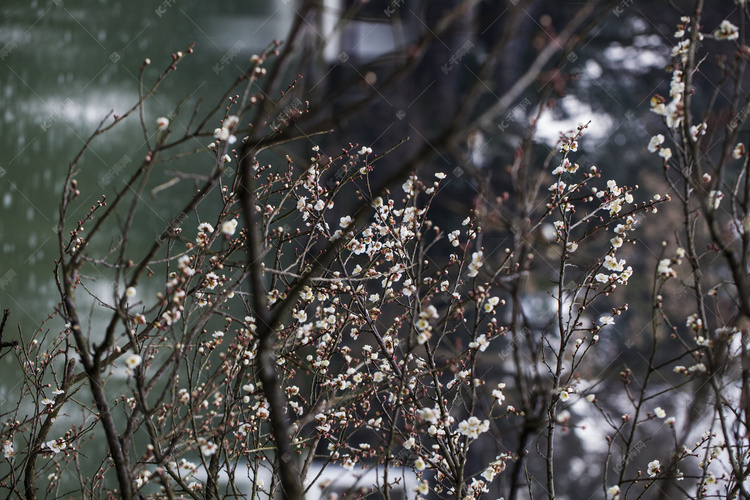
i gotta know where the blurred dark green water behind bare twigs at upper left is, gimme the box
[0,0,293,412]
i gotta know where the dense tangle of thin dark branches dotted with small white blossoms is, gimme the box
[7,8,750,500]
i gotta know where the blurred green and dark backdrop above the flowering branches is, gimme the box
[0,0,700,340]
